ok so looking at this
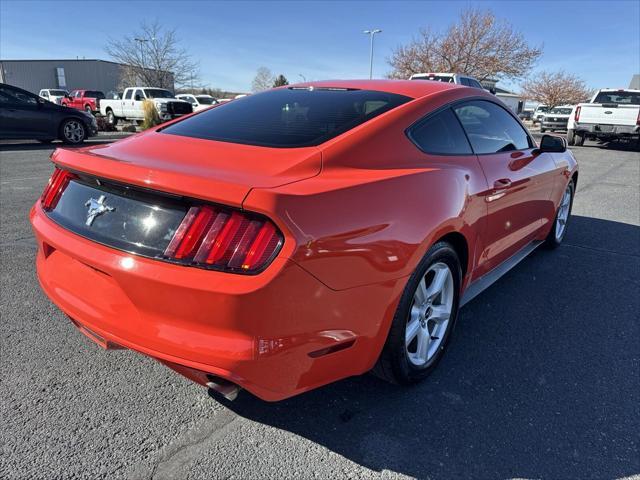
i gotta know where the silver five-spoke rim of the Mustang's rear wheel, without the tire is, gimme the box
[405,262,454,367]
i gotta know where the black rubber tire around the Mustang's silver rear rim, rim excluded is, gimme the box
[372,242,462,385]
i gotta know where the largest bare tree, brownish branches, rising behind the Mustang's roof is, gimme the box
[388,8,542,81]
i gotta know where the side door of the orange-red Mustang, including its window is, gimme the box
[454,100,556,275]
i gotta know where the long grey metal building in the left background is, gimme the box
[0,60,172,94]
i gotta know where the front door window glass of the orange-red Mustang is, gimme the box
[454,100,531,154]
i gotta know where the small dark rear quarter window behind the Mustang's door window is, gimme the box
[409,108,473,155]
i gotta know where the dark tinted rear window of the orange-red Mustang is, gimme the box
[162,88,411,148]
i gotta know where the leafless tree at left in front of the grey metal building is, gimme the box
[105,21,199,89]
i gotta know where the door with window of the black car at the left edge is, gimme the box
[0,85,51,138]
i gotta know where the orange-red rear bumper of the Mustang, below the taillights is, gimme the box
[30,204,404,401]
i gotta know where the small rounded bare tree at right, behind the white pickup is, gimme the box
[522,71,591,108]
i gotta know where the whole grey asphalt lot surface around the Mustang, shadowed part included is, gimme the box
[0,143,640,478]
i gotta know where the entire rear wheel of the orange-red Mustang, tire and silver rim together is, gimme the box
[372,242,462,385]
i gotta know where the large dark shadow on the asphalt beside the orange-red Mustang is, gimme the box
[218,216,640,479]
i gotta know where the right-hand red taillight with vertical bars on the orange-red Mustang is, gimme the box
[164,205,282,273]
